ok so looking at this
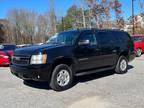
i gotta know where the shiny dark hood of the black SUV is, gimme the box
[14,44,64,56]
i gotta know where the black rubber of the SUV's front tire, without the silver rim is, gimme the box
[50,64,73,91]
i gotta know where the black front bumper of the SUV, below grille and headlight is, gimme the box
[10,64,51,81]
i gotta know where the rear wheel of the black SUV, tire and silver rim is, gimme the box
[115,56,128,74]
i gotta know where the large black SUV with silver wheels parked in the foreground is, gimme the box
[11,29,135,91]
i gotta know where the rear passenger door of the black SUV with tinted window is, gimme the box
[96,31,118,67]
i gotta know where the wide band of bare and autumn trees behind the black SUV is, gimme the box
[0,0,144,44]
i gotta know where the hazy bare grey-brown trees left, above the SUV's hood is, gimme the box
[7,9,53,44]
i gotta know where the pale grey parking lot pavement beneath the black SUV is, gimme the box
[0,56,144,108]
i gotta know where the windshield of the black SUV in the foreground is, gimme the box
[47,31,79,45]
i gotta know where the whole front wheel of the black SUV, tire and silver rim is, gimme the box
[50,64,73,91]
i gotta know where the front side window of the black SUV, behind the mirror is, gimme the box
[79,33,97,45]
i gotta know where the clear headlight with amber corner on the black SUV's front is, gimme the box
[30,53,47,64]
